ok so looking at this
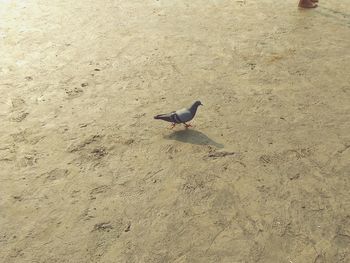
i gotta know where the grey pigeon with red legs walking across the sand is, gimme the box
[154,100,203,129]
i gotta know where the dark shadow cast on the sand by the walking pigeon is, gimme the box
[164,129,224,148]
